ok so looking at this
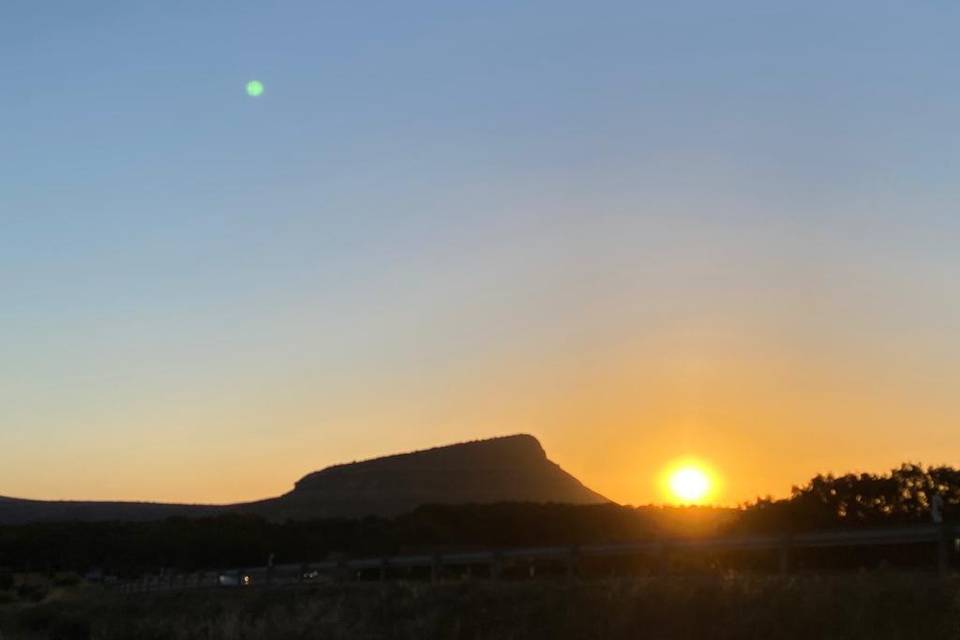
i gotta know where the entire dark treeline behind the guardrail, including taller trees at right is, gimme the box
[0,465,960,576]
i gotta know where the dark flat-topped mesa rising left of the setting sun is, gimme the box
[268,435,609,517]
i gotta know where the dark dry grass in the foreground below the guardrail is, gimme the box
[0,574,960,640]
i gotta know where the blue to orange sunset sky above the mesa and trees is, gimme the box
[0,0,960,505]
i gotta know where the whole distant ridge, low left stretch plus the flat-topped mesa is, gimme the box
[0,434,610,524]
